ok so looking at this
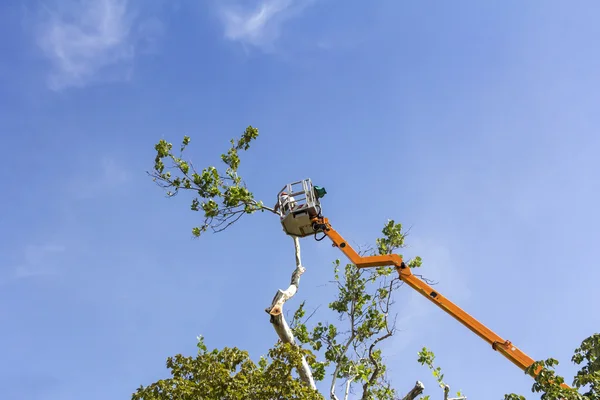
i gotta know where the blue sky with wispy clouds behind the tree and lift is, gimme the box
[0,0,600,400]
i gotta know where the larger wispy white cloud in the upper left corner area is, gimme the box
[37,0,160,90]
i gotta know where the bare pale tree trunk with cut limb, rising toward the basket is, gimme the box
[265,237,317,389]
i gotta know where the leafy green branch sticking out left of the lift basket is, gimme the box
[149,126,270,237]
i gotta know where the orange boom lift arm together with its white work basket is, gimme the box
[275,178,568,387]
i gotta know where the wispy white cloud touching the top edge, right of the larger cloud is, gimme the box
[219,0,314,51]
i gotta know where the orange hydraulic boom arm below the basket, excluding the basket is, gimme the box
[312,217,569,388]
